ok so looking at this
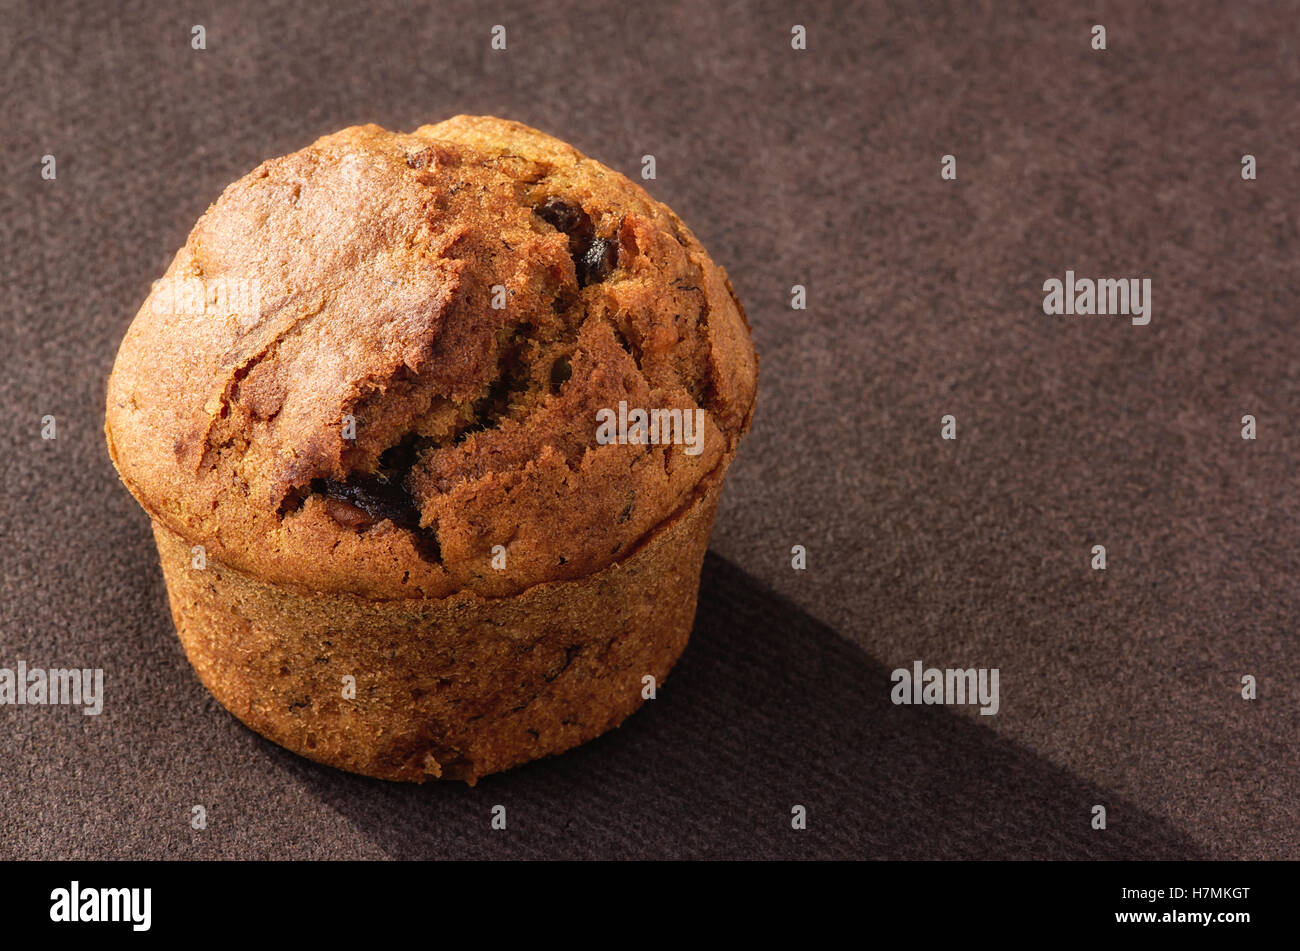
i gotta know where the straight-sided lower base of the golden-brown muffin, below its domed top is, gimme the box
[153,464,727,783]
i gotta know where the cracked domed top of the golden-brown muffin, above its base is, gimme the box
[107,116,757,599]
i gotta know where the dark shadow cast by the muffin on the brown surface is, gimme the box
[267,553,1205,859]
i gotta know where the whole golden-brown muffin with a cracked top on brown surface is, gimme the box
[105,116,758,782]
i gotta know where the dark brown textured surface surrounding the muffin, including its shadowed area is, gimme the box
[0,0,1300,859]
